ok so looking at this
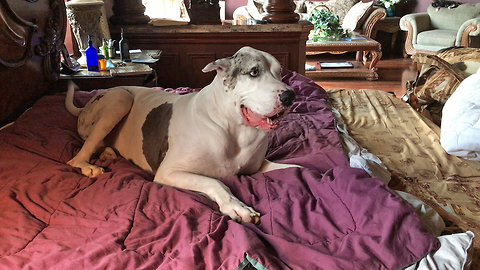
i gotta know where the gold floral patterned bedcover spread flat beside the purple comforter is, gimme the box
[327,90,480,269]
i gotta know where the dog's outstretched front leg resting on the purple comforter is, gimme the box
[154,171,260,224]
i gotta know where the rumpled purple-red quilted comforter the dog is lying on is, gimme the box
[0,71,438,270]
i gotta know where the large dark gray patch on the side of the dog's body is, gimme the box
[142,103,173,171]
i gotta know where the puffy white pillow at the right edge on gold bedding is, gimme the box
[440,69,480,160]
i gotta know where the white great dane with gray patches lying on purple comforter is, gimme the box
[65,47,296,224]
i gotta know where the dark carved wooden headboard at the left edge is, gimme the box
[0,0,67,126]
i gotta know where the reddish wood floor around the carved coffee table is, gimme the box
[307,53,416,97]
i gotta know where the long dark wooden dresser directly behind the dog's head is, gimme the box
[110,21,313,87]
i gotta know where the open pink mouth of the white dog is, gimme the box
[240,105,289,133]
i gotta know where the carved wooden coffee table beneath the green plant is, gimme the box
[306,36,382,80]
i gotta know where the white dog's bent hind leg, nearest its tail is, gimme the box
[68,88,133,177]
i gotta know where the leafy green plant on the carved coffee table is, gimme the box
[306,9,351,42]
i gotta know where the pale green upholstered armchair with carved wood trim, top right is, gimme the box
[400,3,480,55]
